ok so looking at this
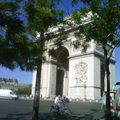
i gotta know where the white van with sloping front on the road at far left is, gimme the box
[0,89,18,100]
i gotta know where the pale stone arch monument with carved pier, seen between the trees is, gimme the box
[32,31,115,100]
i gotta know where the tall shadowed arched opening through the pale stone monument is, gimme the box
[51,46,69,96]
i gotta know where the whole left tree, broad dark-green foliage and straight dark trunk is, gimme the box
[0,0,62,120]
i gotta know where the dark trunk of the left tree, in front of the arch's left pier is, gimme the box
[32,32,45,120]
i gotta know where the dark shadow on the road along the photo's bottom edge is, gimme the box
[0,109,104,120]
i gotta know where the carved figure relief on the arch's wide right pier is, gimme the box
[74,62,88,85]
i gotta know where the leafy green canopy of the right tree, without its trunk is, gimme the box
[73,0,120,45]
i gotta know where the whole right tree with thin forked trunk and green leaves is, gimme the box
[72,0,120,119]
